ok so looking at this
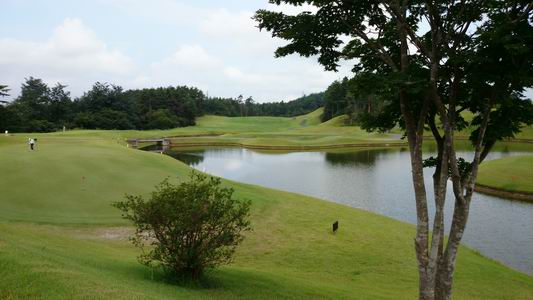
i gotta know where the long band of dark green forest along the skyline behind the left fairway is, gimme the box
[0,77,324,132]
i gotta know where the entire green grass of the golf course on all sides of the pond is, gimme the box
[0,111,533,299]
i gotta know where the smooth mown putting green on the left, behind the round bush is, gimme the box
[0,138,185,224]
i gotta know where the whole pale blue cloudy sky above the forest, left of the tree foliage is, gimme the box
[0,0,351,102]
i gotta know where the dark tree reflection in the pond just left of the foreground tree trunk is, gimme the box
[326,149,398,167]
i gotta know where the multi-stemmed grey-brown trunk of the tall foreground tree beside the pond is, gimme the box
[390,1,490,300]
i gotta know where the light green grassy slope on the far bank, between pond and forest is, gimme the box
[17,109,399,147]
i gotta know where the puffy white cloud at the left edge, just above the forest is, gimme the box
[0,18,135,97]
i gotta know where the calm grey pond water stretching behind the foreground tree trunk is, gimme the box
[167,148,533,275]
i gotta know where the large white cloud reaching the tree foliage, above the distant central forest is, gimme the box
[130,2,351,102]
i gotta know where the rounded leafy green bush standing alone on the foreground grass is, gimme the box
[113,172,251,281]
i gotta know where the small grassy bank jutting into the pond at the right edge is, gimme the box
[478,156,533,193]
